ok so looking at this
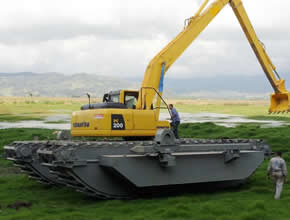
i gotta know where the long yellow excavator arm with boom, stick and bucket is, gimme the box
[137,0,290,116]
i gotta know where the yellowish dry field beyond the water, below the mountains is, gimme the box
[0,97,290,122]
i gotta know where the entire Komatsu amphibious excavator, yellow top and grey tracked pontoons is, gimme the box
[4,0,290,199]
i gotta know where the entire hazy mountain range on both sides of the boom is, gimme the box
[0,72,290,99]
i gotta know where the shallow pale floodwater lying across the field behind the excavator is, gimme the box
[0,113,289,130]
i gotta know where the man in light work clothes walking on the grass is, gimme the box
[267,152,287,199]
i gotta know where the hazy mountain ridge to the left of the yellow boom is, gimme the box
[0,72,140,97]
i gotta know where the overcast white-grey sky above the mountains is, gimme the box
[0,0,290,79]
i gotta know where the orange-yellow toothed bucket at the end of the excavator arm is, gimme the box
[269,92,290,113]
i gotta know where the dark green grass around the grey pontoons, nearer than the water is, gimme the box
[0,123,290,220]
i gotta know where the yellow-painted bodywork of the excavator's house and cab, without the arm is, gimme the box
[71,90,170,137]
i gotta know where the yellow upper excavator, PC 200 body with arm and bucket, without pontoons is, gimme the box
[71,0,290,138]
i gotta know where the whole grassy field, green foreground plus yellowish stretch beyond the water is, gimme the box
[0,97,290,220]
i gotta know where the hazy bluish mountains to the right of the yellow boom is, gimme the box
[164,74,290,99]
